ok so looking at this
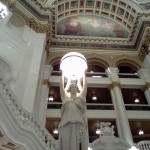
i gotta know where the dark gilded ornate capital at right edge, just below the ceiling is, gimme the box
[139,29,150,61]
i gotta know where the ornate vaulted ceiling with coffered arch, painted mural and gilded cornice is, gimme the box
[12,0,150,51]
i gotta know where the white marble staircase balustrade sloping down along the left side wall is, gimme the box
[0,70,57,150]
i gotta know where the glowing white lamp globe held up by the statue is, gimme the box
[60,52,87,80]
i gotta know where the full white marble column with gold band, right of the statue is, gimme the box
[107,68,133,145]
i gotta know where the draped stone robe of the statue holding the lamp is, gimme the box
[59,97,88,150]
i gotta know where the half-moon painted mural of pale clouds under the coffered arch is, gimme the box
[57,15,129,38]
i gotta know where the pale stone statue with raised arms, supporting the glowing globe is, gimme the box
[59,75,88,150]
